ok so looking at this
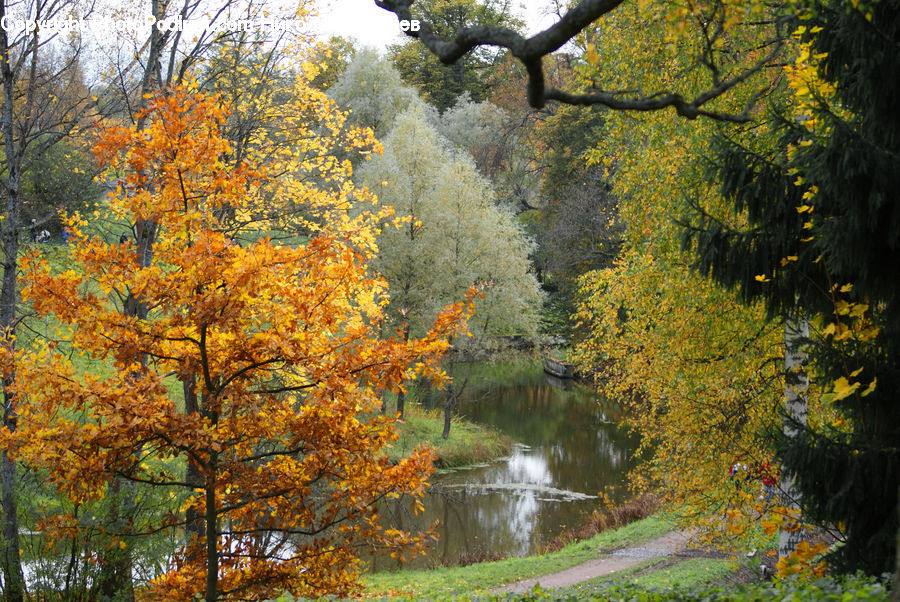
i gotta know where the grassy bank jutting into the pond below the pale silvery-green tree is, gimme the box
[388,405,513,468]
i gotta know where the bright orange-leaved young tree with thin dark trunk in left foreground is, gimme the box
[5,88,468,601]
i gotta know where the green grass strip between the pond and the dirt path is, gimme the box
[363,515,674,599]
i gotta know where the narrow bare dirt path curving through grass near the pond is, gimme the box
[491,531,692,594]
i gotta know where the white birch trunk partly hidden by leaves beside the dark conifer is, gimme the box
[778,316,809,558]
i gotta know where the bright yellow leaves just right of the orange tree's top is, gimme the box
[197,40,380,234]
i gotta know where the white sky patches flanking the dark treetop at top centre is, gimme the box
[313,0,555,50]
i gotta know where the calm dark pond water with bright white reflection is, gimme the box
[372,362,637,570]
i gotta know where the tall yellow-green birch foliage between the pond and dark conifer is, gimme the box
[575,0,816,547]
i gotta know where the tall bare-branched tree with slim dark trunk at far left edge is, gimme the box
[0,1,102,602]
